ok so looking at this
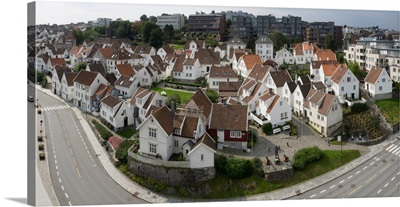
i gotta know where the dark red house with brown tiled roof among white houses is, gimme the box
[207,103,248,150]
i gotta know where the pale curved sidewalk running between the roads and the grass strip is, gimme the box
[36,86,399,203]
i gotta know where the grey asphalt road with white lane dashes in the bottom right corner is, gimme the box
[291,141,400,199]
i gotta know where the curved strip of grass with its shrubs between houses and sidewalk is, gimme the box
[120,147,361,199]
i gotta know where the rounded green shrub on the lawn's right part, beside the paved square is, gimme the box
[293,146,322,169]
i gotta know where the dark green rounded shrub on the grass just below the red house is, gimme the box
[226,157,254,179]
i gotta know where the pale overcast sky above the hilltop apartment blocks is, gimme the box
[36,0,400,30]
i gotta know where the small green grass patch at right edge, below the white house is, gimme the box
[375,98,400,124]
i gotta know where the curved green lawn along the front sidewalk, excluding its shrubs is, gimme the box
[119,150,361,199]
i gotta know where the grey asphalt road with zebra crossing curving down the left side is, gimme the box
[37,90,146,205]
